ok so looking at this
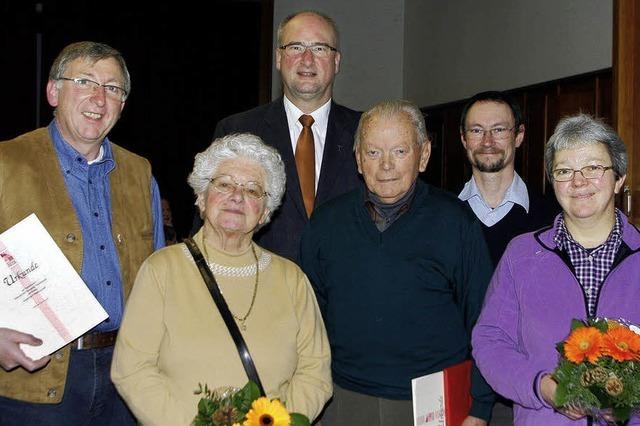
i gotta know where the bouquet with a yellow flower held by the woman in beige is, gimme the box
[191,381,309,426]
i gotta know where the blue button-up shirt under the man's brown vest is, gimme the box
[49,119,165,331]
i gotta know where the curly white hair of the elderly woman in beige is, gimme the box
[187,133,287,224]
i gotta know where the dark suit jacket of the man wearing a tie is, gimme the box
[191,98,360,261]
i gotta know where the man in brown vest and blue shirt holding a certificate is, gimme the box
[0,42,164,425]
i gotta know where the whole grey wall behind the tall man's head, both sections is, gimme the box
[273,0,613,109]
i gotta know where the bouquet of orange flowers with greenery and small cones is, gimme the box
[552,318,640,423]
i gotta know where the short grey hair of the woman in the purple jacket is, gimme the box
[544,114,627,180]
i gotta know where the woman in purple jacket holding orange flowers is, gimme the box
[472,114,640,426]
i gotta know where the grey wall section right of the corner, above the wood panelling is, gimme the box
[403,0,613,106]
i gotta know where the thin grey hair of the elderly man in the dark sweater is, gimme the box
[353,100,429,152]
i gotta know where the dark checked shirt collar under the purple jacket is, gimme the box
[553,209,622,317]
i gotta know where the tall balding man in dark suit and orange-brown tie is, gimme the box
[194,11,360,260]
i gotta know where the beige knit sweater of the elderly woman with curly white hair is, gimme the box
[111,231,332,425]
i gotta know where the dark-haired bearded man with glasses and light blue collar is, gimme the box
[458,91,557,425]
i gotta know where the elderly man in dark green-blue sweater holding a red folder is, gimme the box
[301,101,493,426]
